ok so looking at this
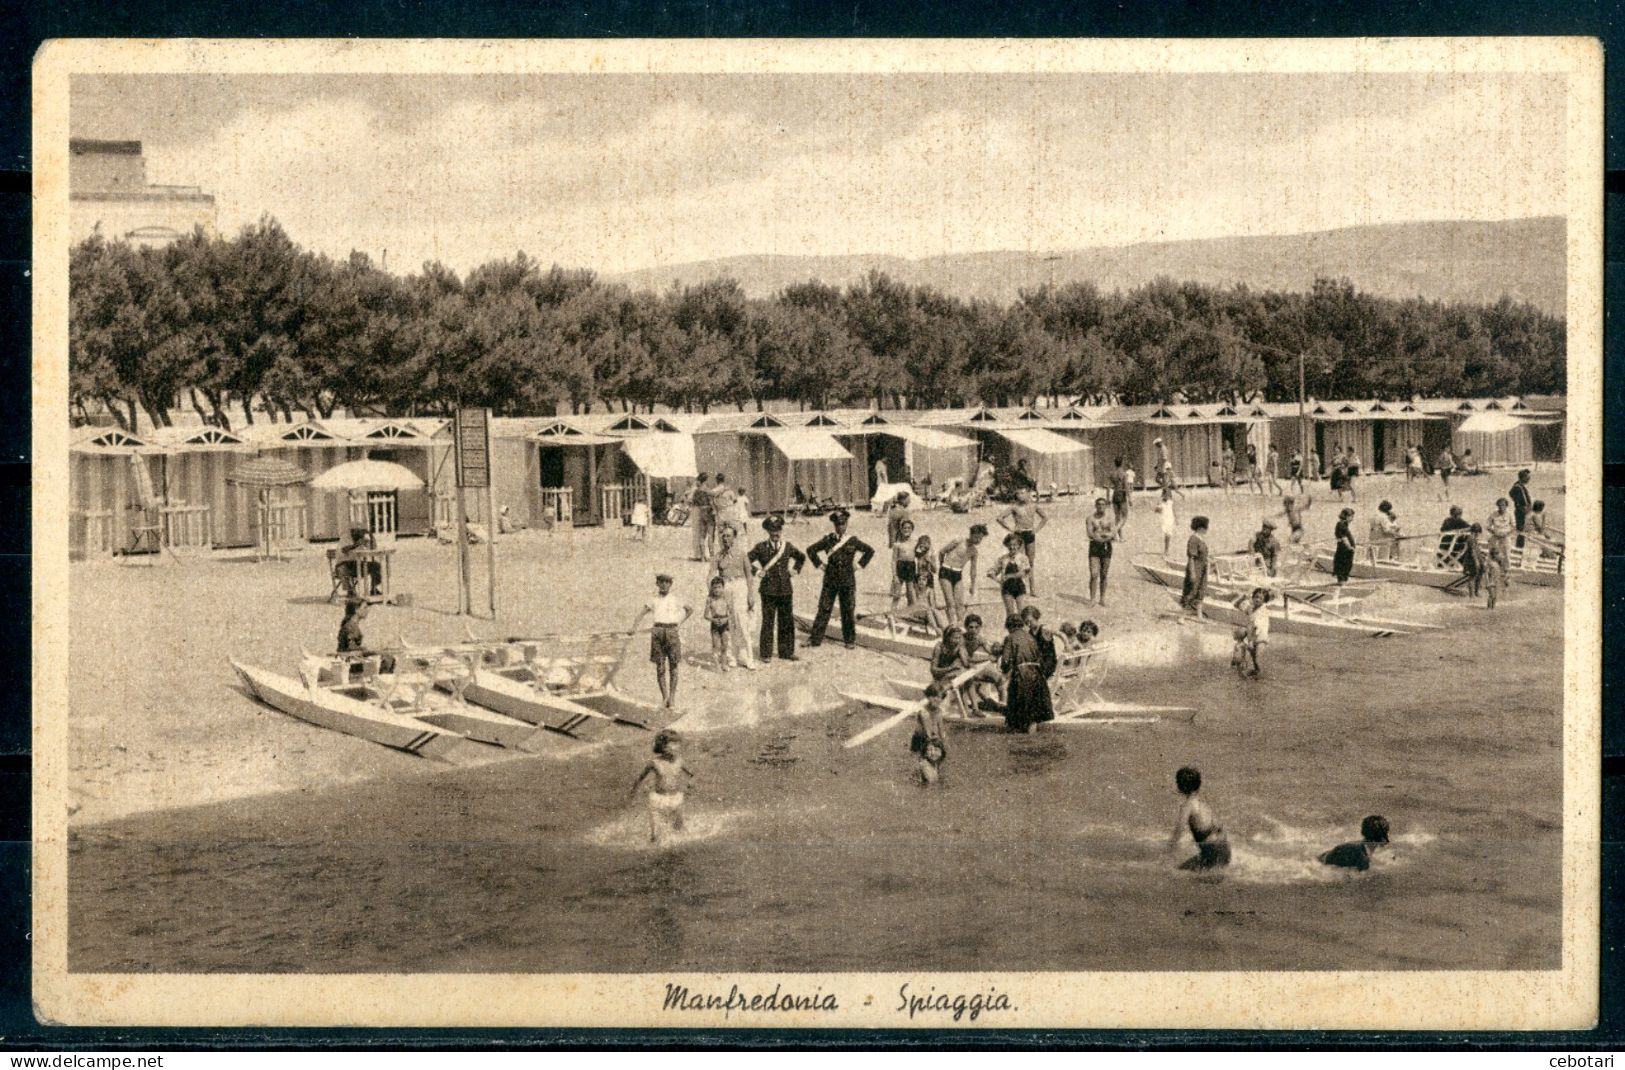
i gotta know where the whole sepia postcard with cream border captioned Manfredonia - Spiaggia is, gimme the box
[33,39,1602,1029]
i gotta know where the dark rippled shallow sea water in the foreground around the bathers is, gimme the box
[70,590,1562,972]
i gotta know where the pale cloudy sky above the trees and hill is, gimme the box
[70,73,1565,273]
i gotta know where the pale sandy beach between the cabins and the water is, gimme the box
[70,468,1562,824]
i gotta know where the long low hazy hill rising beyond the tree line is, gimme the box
[609,216,1567,315]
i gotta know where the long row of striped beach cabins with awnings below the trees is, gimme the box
[70,397,1565,558]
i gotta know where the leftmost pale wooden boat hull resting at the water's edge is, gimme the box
[231,660,492,766]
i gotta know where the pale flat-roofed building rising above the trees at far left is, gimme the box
[68,138,215,246]
